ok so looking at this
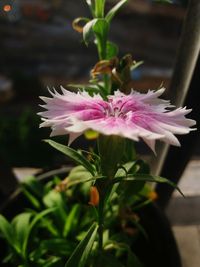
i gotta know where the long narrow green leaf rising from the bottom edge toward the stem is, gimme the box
[65,223,98,267]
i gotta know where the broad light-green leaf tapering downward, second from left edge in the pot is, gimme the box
[12,212,32,251]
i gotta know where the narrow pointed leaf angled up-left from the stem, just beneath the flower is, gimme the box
[45,140,95,175]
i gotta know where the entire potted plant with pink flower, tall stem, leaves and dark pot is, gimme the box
[0,0,195,267]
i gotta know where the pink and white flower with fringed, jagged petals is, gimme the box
[39,87,195,151]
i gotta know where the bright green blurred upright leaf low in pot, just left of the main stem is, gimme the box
[63,204,81,237]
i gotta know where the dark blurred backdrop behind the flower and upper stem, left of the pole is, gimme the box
[0,0,192,170]
